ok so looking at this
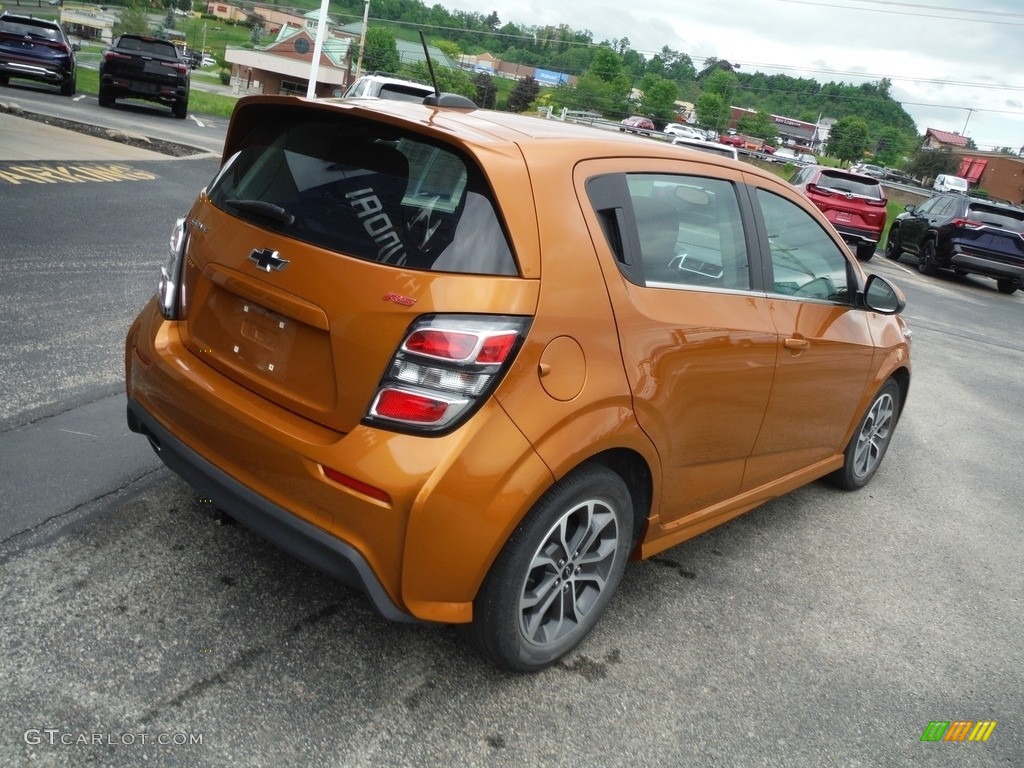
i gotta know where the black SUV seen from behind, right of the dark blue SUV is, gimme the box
[99,35,190,119]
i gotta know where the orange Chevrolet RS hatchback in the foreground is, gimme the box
[125,96,910,671]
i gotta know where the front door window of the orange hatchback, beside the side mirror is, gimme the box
[757,189,851,303]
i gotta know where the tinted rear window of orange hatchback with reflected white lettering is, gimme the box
[210,111,518,274]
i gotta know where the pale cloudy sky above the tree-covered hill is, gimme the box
[440,0,1024,150]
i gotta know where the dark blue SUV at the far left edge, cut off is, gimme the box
[0,13,78,96]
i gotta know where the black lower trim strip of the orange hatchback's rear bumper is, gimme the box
[128,399,417,622]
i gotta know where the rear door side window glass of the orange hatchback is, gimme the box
[627,173,751,291]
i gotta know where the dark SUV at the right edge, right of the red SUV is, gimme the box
[886,193,1024,294]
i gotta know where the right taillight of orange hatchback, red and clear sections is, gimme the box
[366,314,529,433]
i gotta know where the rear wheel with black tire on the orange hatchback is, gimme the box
[467,464,633,672]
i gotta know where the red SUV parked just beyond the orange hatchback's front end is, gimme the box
[790,165,888,261]
